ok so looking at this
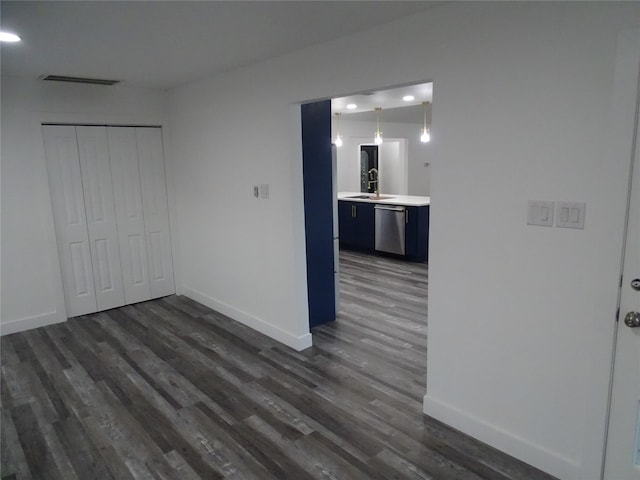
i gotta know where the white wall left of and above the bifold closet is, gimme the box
[0,77,167,334]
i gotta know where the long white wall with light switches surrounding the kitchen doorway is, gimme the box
[170,2,640,479]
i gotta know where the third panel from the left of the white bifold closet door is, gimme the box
[107,127,151,304]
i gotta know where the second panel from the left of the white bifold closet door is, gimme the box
[76,127,125,310]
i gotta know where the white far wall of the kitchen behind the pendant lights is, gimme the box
[332,115,432,196]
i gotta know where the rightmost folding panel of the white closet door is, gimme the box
[136,127,176,298]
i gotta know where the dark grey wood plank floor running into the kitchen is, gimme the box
[1,252,551,480]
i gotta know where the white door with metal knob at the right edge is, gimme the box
[604,87,640,480]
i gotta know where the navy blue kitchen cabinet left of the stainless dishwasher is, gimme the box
[338,200,375,250]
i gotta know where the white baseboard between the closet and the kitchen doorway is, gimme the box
[181,285,312,351]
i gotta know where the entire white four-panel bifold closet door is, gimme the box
[43,125,175,316]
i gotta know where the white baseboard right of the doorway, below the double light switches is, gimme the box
[422,394,581,480]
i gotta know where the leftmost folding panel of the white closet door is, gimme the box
[42,125,97,317]
